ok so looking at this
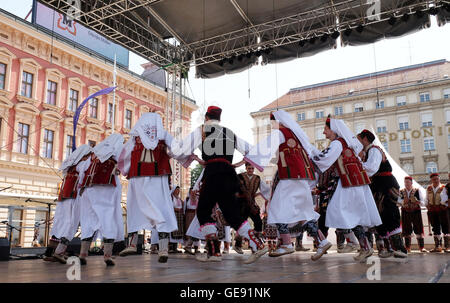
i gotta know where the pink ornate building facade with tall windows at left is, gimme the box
[0,12,197,247]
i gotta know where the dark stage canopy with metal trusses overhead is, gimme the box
[38,0,450,78]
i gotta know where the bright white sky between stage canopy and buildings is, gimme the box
[0,0,450,143]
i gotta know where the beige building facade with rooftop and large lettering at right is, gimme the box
[251,60,450,184]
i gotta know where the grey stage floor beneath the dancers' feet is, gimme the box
[0,250,450,283]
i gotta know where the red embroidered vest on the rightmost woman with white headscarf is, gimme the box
[334,138,370,187]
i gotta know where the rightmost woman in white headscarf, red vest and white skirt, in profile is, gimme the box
[302,116,381,261]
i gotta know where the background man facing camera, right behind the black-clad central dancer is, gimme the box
[233,162,270,254]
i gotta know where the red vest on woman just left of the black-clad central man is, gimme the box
[127,140,172,179]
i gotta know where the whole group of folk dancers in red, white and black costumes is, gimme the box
[46,106,450,266]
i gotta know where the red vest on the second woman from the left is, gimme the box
[81,158,117,187]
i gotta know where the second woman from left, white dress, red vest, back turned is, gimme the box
[79,133,124,266]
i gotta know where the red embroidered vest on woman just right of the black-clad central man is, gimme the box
[278,128,315,180]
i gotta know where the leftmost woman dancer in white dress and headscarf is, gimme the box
[51,144,92,264]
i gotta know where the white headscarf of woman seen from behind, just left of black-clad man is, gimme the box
[130,113,164,150]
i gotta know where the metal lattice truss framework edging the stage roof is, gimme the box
[39,0,449,67]
